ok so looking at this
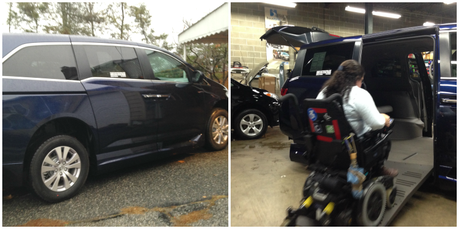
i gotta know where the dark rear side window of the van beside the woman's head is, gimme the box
[302,42,354,76]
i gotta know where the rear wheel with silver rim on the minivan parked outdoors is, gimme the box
[29,135,89,203]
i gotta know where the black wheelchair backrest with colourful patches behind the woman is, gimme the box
[303,94,353,169]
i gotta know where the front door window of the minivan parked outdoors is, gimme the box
[145,50,188,82]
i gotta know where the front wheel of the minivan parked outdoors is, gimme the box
[206,108,228,150]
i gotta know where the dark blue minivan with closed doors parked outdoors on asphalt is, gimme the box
[2,34,228,202]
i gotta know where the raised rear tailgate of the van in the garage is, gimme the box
[260,26,339,49]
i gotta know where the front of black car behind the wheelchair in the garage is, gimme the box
[231,79,279,139]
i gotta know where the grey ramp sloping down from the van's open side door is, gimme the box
[381,137,433,226]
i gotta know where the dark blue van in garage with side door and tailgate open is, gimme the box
[262,23,457,190]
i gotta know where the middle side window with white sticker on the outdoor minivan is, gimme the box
[84,45,144,79]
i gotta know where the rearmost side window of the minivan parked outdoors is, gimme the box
[3,45,78,80]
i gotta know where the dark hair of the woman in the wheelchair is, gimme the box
[322,60,365,101]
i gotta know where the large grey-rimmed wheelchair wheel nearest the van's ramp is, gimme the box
[357,182,386,226]
